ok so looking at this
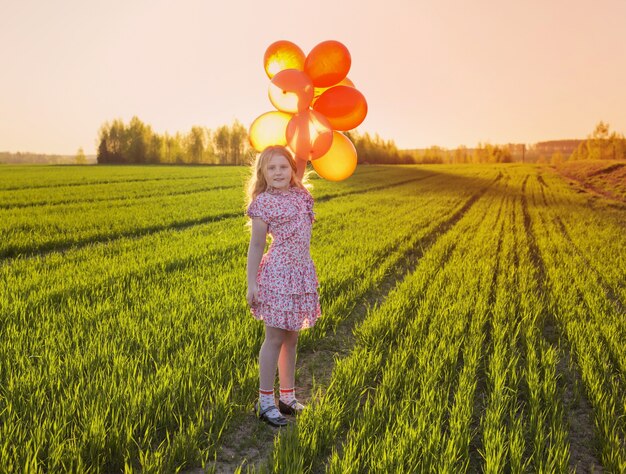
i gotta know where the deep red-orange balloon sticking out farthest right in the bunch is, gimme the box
[313,86,367,130]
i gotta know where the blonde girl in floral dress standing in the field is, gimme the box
[246,146,320,426]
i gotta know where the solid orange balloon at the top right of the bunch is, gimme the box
[304,40,352,87]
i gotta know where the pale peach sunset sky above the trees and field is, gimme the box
[0,0,626,154]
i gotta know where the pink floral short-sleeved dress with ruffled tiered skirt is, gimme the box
[247,187,321,331]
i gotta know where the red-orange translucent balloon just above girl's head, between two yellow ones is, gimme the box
[287,110,333,160]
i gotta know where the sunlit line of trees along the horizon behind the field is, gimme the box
[94,117,626,165]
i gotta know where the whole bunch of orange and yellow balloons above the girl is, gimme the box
[249,40,367,181]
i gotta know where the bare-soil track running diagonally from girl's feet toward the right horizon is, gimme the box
[207,173,502,474]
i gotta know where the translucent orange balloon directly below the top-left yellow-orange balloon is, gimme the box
[268,69,313,113]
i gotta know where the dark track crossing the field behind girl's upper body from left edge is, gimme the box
[0,173,437,263]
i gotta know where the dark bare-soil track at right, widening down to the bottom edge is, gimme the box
[522,175,602,470]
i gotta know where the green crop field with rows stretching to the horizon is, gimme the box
[0,164,626,473]
